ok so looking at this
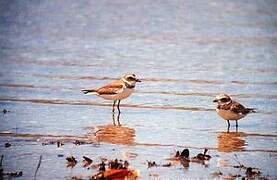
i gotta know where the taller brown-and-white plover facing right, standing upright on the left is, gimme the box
[82,74,141,113]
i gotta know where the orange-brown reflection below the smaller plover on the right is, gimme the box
[217,132,246,152]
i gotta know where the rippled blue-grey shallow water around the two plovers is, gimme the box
[0,0,277,179]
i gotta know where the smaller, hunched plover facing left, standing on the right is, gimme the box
[213,94,255,131]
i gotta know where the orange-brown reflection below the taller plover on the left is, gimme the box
[91,114,135,145]
